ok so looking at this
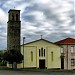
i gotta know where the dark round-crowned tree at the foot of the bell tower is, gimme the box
[3,49,23,68]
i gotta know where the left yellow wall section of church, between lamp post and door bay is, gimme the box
[21,46,36,68]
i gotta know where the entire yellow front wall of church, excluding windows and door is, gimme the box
[21,40,61,69]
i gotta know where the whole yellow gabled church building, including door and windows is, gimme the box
[18,39,61,69]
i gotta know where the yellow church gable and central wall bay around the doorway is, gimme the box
[25,40,50,68]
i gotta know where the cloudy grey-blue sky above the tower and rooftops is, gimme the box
[0,0,75,50]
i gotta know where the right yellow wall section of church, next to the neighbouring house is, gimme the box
[47,46,61,68]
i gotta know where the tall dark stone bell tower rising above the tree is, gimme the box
[7,9,21,50]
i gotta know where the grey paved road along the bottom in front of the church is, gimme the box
[0,70,75,75]
